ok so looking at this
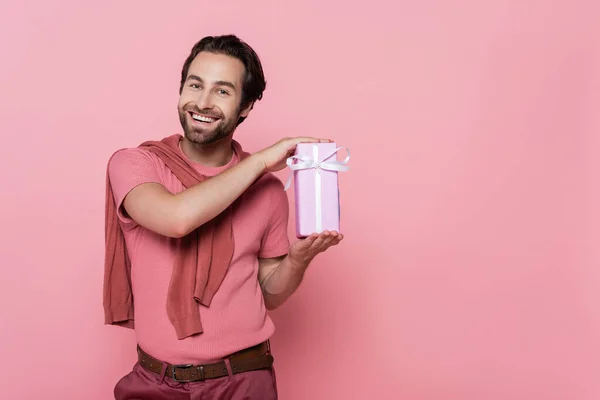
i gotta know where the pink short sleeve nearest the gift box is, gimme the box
[258,175,290,258]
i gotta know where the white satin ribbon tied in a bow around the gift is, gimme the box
[284,145,350,232]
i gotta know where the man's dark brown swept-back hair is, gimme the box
[179,35,267,125]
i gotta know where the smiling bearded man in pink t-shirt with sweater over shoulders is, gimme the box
[104,35,343,400]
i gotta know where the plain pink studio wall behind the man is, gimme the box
[0,0,600,400]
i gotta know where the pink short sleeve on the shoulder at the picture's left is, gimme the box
[108,148,162,227]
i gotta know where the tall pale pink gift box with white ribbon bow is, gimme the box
[286,143,350,238]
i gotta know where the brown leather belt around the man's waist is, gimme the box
[138,341,273,382]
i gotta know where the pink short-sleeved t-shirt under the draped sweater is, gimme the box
[108,141,289,364]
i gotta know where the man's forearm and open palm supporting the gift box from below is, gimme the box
[258,231,344,310]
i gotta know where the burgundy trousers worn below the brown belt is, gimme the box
[115,363,277,400]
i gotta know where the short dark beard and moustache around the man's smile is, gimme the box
[179,106,240,144]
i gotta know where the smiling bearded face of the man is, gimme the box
[177,51,251,144]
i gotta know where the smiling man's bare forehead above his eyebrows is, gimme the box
[188,51,246,86]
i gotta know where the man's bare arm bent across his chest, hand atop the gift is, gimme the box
[118,137,328,237]
